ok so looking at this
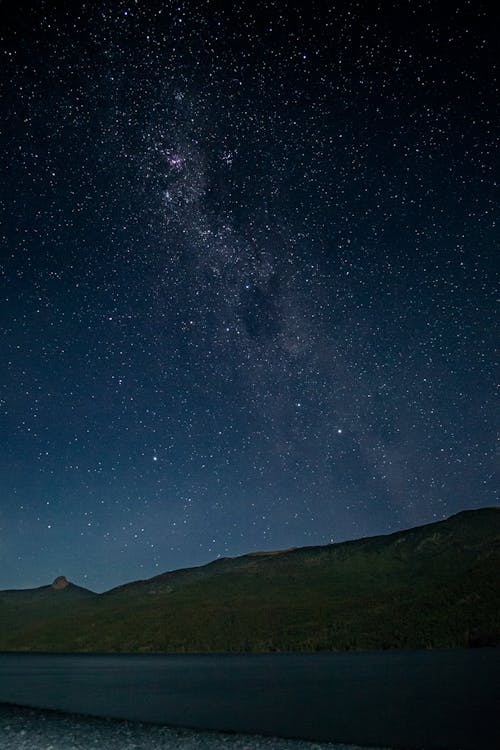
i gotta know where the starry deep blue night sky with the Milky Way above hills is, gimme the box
[0,0,500,591]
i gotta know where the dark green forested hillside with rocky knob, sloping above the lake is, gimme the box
[0,508,500,652]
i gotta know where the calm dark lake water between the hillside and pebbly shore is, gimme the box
[0,649,500,750]
